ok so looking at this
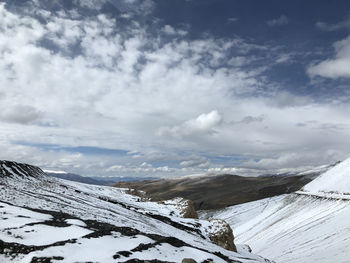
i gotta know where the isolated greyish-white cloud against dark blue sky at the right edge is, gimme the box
[307,36,350,79]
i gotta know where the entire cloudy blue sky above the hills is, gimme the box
[0,0,350,177]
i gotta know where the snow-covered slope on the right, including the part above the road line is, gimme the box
[201,159,350,263]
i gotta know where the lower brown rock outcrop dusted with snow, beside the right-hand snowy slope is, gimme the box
[205,219,237,252]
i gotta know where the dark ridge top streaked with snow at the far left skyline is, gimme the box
[0,160,46,178]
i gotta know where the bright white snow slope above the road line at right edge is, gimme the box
[301,158,350,198]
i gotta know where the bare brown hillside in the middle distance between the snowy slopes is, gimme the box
[115,166,329,210]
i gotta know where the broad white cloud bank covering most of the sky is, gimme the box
[0,0,350,175]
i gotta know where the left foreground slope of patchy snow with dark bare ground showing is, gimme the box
[0,161,270,263]
